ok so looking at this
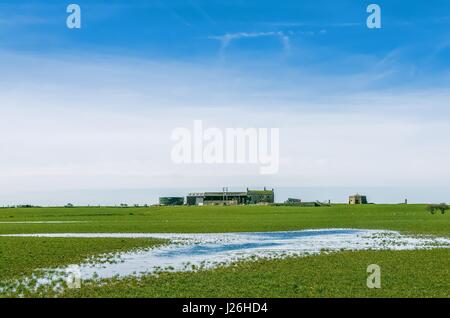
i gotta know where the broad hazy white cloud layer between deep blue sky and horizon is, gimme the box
[0,50,450,204]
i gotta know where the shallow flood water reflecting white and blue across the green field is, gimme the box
[0,229,450,291]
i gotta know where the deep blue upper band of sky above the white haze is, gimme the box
[0,0,450,74]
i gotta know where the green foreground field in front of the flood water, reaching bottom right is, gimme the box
[58,249,450,298]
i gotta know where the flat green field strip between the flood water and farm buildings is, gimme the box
[0,205,450,236]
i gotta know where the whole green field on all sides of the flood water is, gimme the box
[0,205,450,297]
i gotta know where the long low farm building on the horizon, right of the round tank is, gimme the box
[186,188,275,205]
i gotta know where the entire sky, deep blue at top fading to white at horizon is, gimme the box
[0,0,450,204]
